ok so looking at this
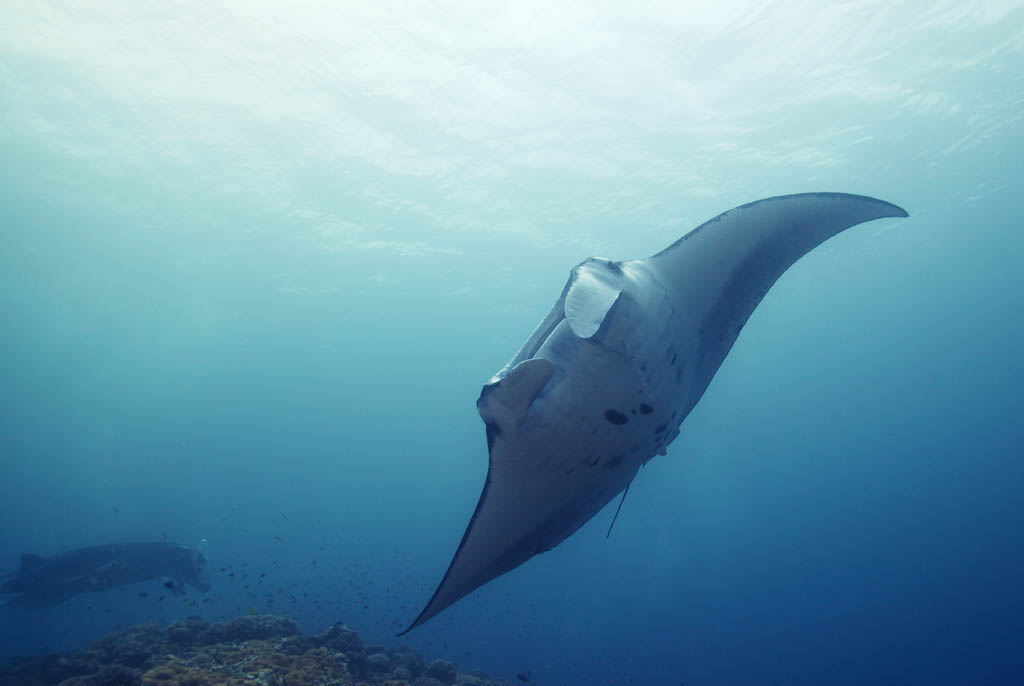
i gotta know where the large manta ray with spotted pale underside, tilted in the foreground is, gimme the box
[399,192,907,636]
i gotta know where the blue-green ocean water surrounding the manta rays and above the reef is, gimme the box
[0,0,1024,686]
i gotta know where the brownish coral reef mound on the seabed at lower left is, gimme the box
[0,614,505,686]
